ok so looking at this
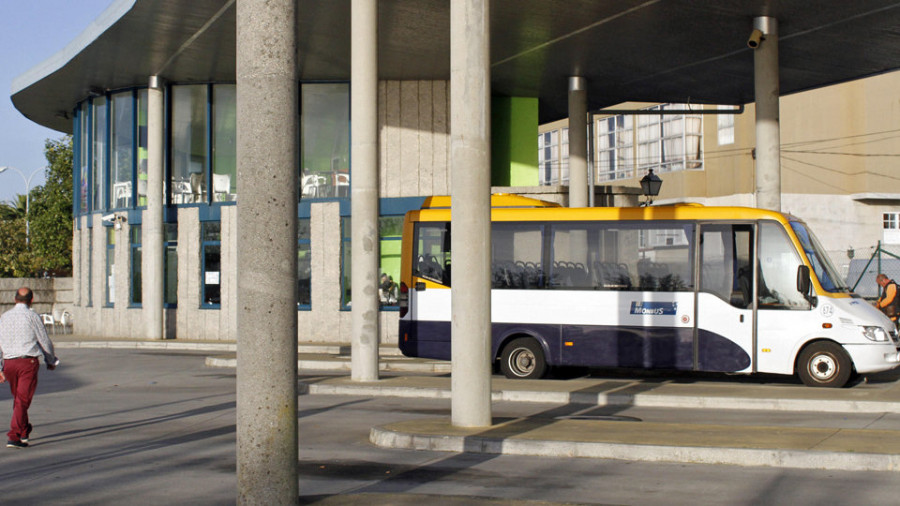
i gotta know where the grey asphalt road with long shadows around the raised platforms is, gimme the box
[0,349,900,506]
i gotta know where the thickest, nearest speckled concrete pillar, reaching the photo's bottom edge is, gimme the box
[236,0,299,505]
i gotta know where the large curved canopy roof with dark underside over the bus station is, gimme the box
[12,0,900,131]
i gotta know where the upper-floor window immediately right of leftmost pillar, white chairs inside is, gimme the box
[169,85,208,204]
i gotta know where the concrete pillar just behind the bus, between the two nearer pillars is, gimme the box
[350,0,379,381]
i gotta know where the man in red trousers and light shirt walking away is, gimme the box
[0,286,59,448]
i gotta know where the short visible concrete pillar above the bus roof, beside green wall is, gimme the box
[569,77,588,207]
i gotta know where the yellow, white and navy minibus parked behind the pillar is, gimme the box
[399,195,900,387]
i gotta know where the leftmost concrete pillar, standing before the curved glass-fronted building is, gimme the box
[141,76,166,339]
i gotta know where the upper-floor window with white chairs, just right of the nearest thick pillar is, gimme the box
[300,83,350,198]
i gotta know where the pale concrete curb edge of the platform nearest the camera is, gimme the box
[369,426,900,472]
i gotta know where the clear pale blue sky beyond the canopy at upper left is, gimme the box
[0,0,113,202]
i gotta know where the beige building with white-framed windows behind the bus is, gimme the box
[538,72,900,272]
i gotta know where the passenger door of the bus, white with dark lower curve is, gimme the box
[693,223,755,372]
